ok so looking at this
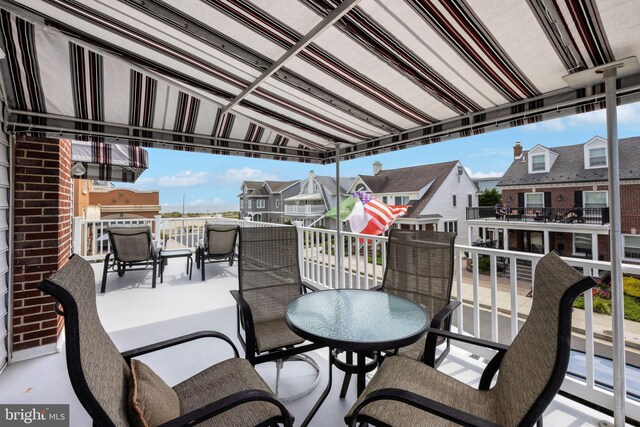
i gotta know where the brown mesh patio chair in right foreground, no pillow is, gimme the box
[345,252,596,426]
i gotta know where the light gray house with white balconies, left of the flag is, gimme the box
[284,171,355,227]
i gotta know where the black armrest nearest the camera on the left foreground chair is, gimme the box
[160,389,292,427]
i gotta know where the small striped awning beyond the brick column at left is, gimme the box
[71,141,149,182]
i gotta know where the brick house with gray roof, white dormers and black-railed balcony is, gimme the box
[468,136,640,263]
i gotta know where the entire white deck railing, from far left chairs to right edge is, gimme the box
[74,217,640,420]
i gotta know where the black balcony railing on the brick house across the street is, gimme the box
[467,207,609,225]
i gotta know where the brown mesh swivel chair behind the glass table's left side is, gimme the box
[231,226,322,397]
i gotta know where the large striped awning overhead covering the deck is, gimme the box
[0,0,640,163]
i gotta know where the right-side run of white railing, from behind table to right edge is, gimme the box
[298,227,640,420]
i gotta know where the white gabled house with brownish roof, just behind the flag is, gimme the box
[349,160,478,243]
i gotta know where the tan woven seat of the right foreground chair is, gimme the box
[347,356,497,427]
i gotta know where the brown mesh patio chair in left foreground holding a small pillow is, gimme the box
[38,255,292,427]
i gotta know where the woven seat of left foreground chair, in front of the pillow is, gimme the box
[173,359,281,427]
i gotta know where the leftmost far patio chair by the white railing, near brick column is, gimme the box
[100,224,159,293]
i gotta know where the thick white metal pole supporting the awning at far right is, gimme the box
[594,67,627,426]
